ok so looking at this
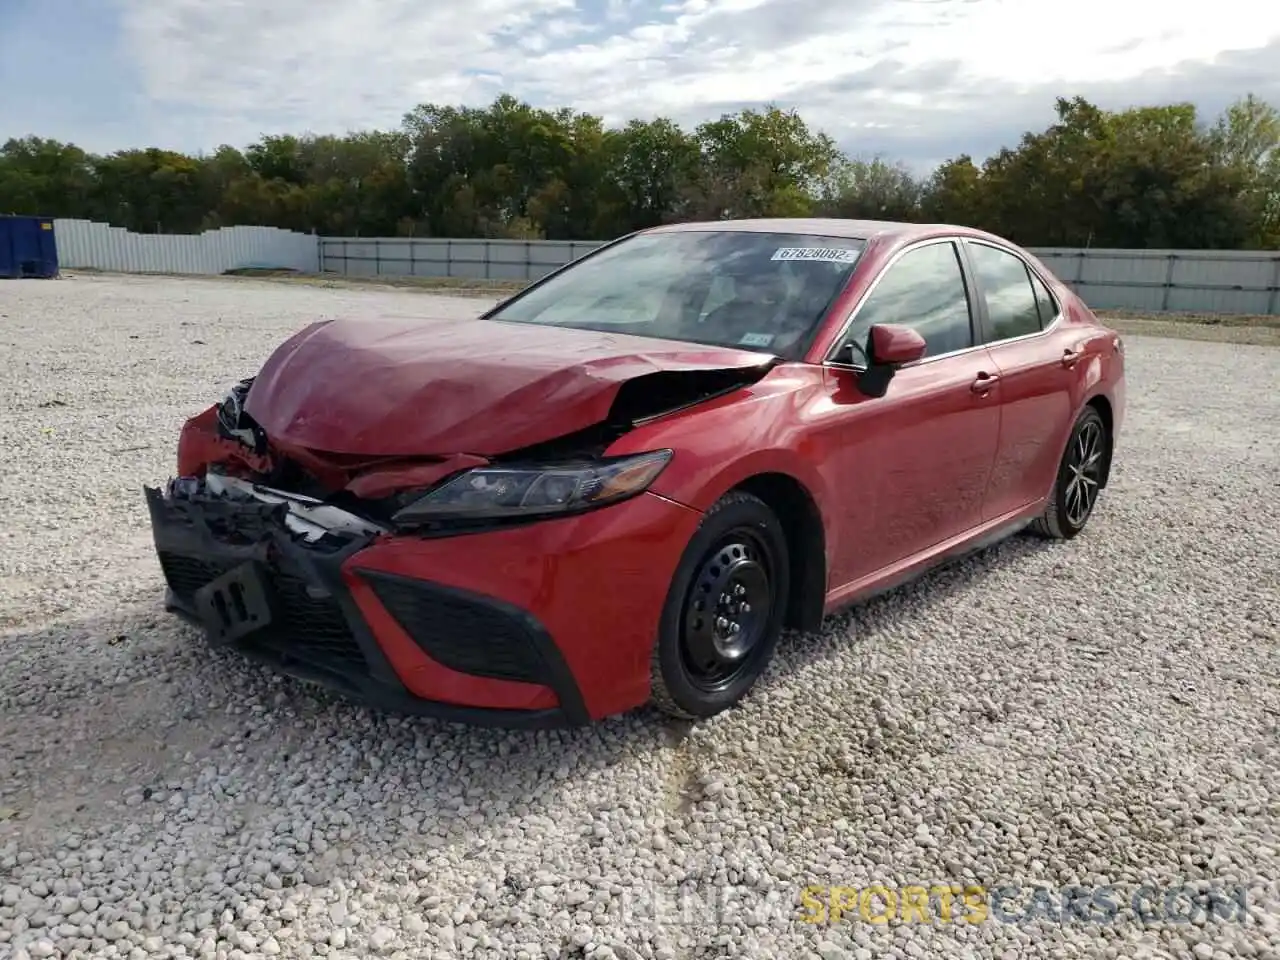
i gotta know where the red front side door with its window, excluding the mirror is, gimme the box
[827,239,1001,589]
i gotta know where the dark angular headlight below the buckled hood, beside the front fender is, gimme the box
[392,451,672,525]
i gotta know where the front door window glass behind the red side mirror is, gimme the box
[846,241,973,362]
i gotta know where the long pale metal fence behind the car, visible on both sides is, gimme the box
[37,220,1280,315]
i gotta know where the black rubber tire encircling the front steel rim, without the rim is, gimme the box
[657,495,791,717]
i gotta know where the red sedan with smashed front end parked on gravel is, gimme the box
[146,219,1124,726]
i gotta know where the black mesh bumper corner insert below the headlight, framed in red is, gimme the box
[361,571,549,684]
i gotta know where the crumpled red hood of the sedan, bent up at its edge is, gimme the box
[244,317,772,456]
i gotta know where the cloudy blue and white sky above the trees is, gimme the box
[0,0,1280,169]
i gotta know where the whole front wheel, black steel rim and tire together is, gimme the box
[650,493,791,719]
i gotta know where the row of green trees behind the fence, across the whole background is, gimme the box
[0,95,1280,250]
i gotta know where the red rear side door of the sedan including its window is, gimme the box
[963,239,1082,520]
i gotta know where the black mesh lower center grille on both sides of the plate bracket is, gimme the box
[160,553,369,675]
